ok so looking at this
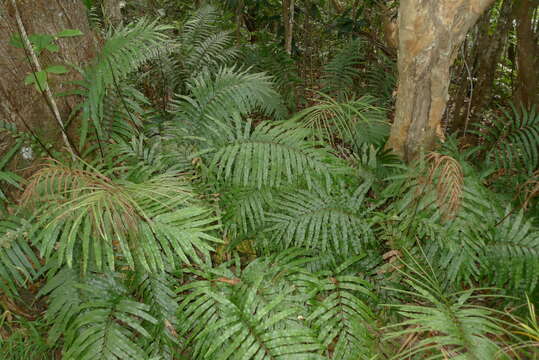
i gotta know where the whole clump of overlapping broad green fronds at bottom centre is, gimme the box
[179,249,382,359]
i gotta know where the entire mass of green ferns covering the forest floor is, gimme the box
[0,2,539,360]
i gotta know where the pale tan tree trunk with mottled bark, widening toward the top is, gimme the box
[388,0,494,161]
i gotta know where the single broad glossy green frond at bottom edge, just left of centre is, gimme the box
[180,250,323,360]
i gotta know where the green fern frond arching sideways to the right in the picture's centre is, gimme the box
[200,117,344,189]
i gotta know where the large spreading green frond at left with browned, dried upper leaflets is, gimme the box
[26,165,220,273]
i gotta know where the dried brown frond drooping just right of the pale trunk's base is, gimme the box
[427,152,464,219]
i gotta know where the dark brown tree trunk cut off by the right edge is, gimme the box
[515,0,539,108]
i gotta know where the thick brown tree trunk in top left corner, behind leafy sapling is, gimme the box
[0,0,95,149]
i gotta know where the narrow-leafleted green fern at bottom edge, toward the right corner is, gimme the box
[387,260,505,360]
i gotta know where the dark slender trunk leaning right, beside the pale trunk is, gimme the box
[451,0,514,131]
